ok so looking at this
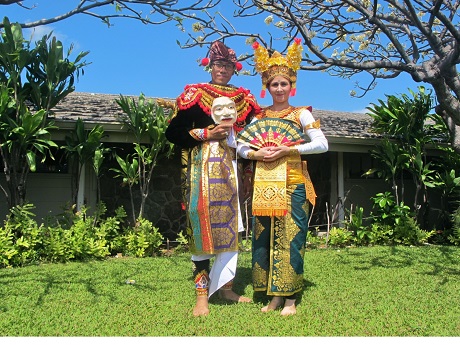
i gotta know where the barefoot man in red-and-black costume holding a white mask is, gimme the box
[166,41,260,316]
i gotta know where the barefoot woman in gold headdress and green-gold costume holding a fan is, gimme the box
[237,39,328,316]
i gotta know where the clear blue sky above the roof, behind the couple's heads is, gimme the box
[0,0,426,112]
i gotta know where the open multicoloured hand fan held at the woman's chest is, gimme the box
[237,118,305,149]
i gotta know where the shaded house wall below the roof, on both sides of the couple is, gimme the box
[0,145,446,236]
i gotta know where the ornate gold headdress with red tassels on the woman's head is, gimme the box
[252,38,303,98]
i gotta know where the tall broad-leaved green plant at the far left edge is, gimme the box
[0,18,87,209]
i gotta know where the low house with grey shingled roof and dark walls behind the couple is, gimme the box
[0,92,434,240]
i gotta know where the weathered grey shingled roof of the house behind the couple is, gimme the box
[53,92,378,139]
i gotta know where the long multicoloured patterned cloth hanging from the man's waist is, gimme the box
[187,140,242,255]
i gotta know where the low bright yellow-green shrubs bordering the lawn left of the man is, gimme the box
[0,200,163,267]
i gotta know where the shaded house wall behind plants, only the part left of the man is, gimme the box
[0,146,185,240]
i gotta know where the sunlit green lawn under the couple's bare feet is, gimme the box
[0,246,460,337]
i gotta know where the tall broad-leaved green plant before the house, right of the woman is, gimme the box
[365,87,452,224]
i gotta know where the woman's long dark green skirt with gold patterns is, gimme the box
[252,183,309,296]
